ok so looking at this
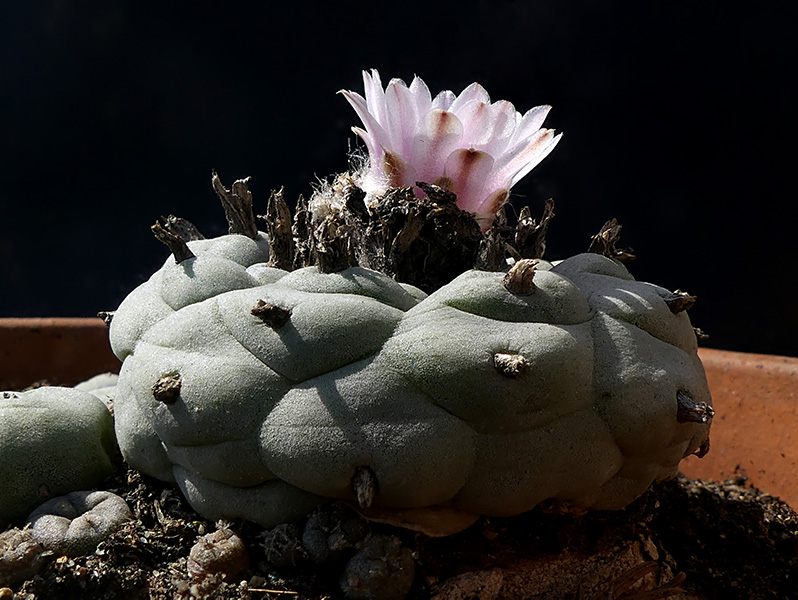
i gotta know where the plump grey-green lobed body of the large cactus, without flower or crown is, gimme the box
[110,213,710,526]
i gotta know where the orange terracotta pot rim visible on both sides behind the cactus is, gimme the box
[0,319,798,507]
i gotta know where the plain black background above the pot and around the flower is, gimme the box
[0,0,798,356]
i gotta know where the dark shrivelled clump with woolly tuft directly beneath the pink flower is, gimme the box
[294,175,554,292]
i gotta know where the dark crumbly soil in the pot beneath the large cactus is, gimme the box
[0,465,798,600]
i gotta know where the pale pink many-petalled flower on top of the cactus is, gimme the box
[341,69,562,230]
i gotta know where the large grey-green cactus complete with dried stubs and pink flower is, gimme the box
[110,71,712,534]
